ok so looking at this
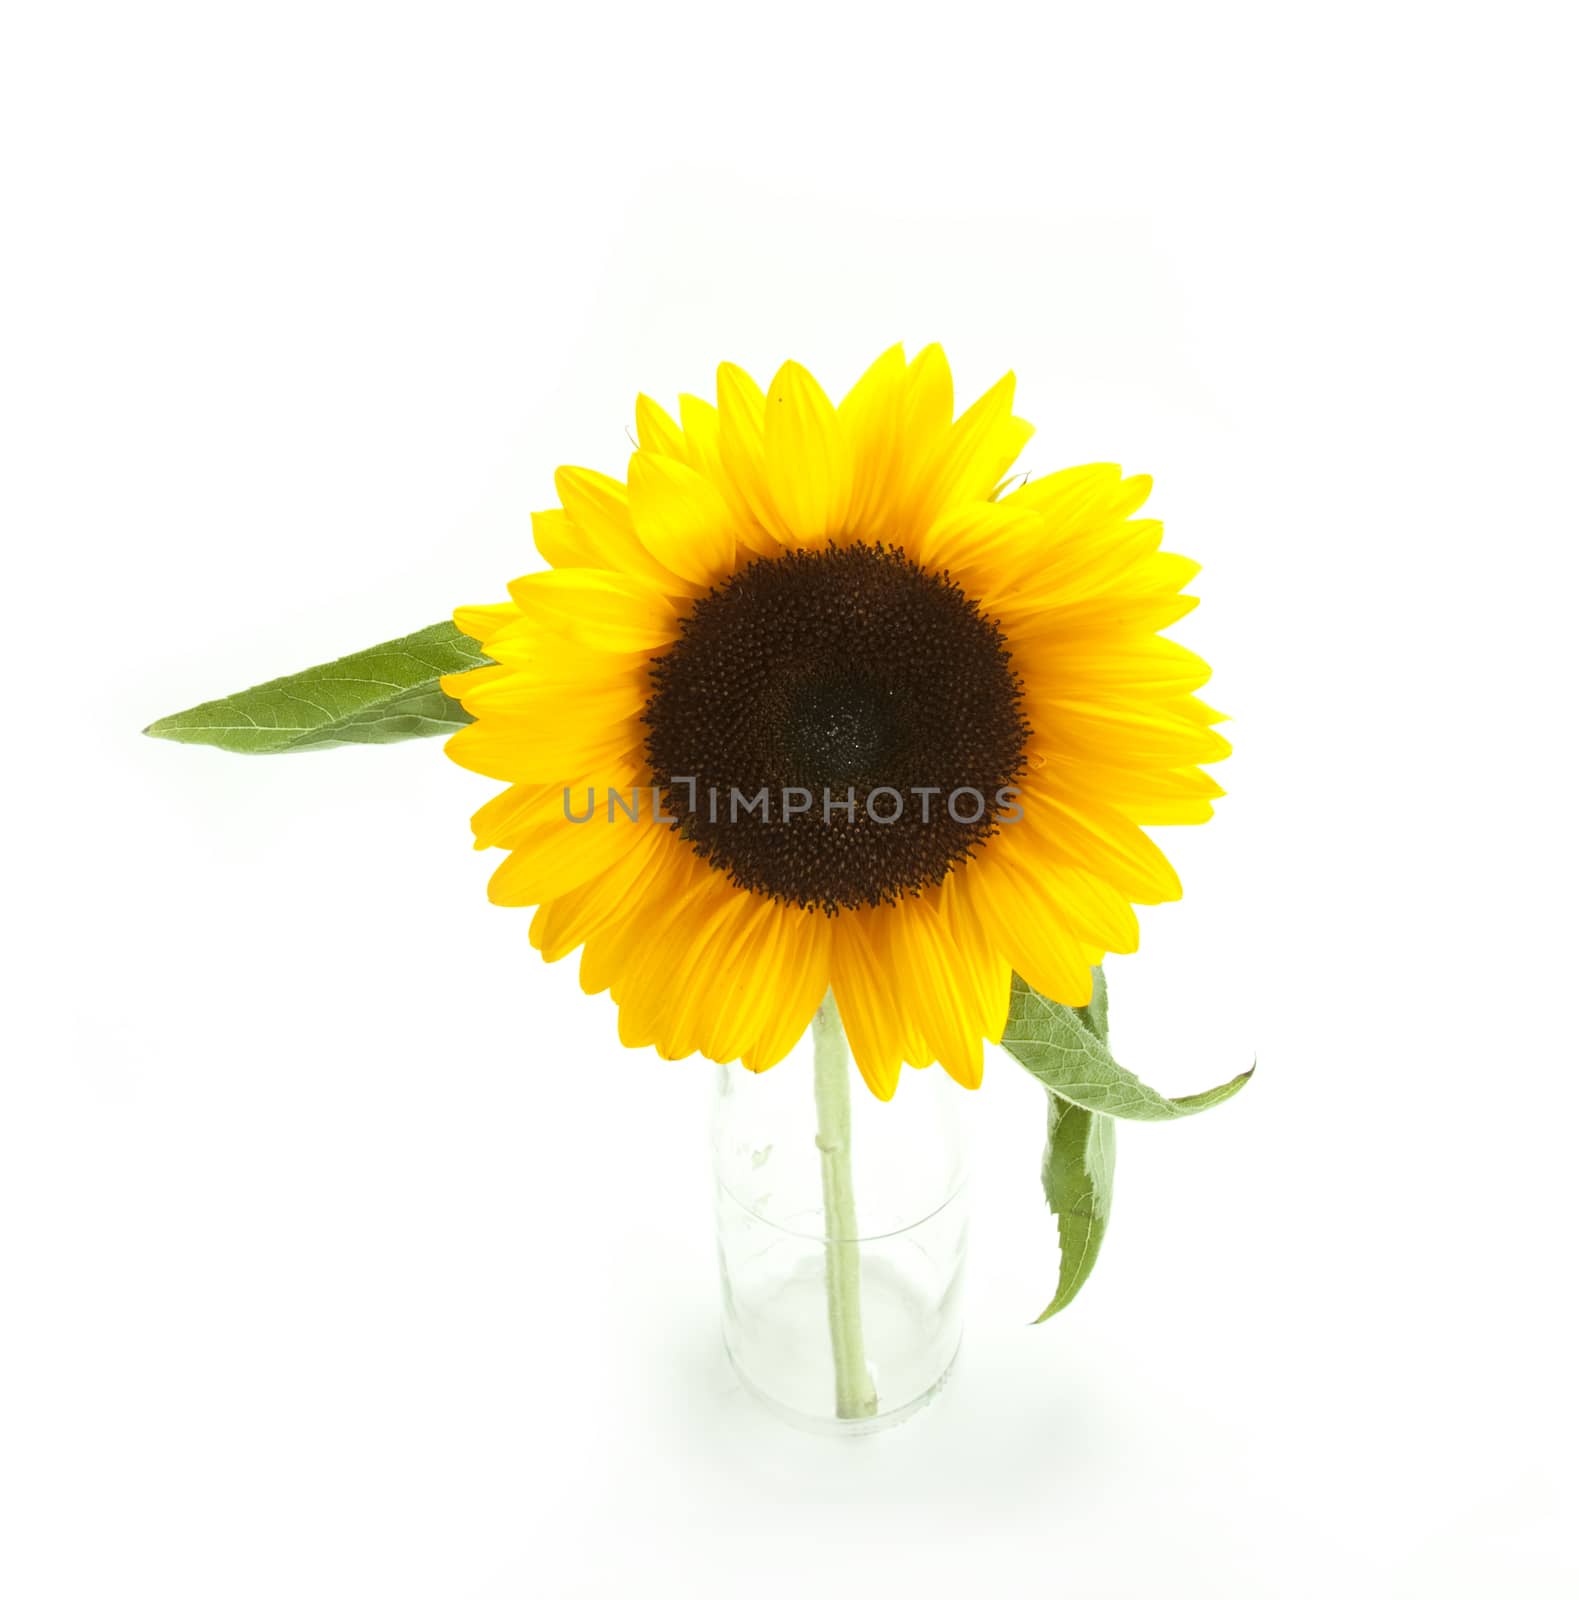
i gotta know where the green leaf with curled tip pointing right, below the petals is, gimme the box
[1003,973,1256,1122]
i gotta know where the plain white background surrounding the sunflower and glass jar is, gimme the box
[0,0,1579,1600]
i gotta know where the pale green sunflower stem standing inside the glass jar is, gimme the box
[811,992,877,1418]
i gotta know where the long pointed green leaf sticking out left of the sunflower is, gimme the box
[142,622,488,755]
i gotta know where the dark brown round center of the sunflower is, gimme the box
[642,544,1029,914]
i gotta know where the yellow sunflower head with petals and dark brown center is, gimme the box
[445,346,1229,1099]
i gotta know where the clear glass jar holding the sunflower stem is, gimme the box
[714,997,966,1434]
